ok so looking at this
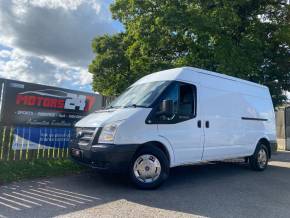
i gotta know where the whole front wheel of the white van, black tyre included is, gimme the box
[129,145,169,189]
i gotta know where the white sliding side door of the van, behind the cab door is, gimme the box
[200,86,249,160]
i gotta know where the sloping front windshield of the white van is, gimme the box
[108,81,170,108]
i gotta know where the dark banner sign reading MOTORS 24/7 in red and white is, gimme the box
[1,80,102,127]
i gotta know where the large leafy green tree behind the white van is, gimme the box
[89,0,290,105]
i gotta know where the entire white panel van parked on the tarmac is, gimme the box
[70,67,277,188]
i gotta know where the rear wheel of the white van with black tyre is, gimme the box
[249,143,269,171]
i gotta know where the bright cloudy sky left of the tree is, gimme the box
[0,0,122,91]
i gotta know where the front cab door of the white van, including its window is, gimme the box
[153,81,204,165]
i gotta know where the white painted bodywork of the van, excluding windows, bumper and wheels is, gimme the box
[70,67,276,172]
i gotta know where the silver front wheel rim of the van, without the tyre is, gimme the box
[134,154,161,183]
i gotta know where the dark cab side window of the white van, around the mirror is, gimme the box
[146,82,196,124]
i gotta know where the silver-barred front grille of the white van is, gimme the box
[76,128,96,149]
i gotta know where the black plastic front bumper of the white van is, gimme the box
[69,143,138,171]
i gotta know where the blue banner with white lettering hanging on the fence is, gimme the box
[12,127,73,150]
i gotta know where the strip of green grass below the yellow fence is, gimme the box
[0,159,85,185]
